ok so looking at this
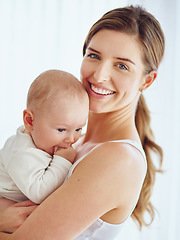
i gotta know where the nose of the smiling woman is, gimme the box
[94,62,111,82]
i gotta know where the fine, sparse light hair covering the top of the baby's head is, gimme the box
[27,69,88,108]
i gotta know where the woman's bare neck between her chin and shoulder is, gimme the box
[84,103,138,143]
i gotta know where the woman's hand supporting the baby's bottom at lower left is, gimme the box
[0,200,38,233]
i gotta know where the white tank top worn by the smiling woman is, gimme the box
[66,139,146,240]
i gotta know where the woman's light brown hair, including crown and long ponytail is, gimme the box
[83,6,165,229]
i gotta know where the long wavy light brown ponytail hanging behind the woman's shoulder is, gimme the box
[132,94,163,229]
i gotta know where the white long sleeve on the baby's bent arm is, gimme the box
[7,148,72,204]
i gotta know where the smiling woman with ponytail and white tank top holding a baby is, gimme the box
[0,6,164,240]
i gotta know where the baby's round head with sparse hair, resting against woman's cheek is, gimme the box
[23,70,89,155]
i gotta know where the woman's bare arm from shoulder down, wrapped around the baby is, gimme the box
[0,143,145,240]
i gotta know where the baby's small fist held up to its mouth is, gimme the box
[54,146,76,163]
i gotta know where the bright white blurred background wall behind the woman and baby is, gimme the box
[0,0,180,240]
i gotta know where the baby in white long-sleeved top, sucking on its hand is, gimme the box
[0,70,89,204]
